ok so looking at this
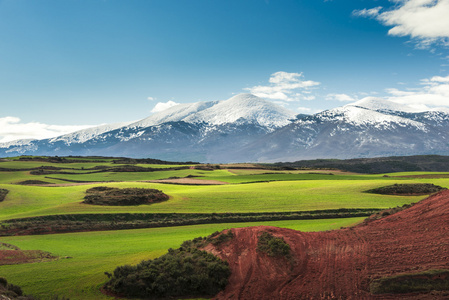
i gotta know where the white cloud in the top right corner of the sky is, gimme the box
[353,0,449,47]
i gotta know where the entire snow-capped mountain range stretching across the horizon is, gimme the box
[0,94,449,163]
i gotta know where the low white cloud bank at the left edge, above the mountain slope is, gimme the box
[0,117,93,143]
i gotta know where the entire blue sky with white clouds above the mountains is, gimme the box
[0,0,449,142]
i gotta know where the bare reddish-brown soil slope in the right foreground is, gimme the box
[206,190,449,299]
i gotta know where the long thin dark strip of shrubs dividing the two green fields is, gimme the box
[0,209,380,236]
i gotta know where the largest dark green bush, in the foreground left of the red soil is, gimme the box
[105,238,231,298]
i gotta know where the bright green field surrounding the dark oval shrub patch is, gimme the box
[0,179,430,220]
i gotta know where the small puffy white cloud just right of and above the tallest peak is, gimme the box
[244,71,320,102]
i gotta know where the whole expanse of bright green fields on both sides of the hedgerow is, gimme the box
[0,158,449,299]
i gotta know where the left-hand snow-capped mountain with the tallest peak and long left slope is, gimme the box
[0,94,296,161]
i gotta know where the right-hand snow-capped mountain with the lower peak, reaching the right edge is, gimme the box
[241,102,449,162]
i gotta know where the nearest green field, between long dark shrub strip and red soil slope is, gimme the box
[0,218,363,299]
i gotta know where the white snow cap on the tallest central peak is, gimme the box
[184,94,296,128]
